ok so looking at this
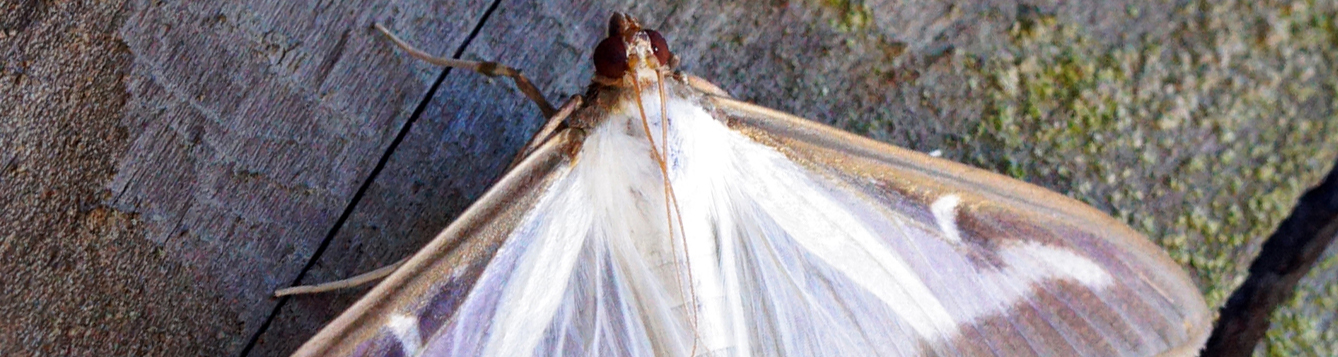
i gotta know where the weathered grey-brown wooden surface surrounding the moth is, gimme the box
[0,0,1338,356]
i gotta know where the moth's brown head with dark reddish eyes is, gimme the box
[594,12,678,86]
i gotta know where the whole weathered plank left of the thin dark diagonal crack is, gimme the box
[0,1,487,356]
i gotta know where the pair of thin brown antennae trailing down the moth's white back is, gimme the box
[630,72,701,356]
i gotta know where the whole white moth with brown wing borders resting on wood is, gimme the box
[297,13,1210,356]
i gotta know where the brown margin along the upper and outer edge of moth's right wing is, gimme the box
[704,96,1211,356]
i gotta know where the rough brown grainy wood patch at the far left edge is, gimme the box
[0,1,241,356]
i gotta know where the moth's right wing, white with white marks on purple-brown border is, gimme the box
[655,95,1207,356]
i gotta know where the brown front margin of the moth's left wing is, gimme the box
[293,130,585,356]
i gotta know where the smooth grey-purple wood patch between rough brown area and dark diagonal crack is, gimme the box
[108,1,503,350]
